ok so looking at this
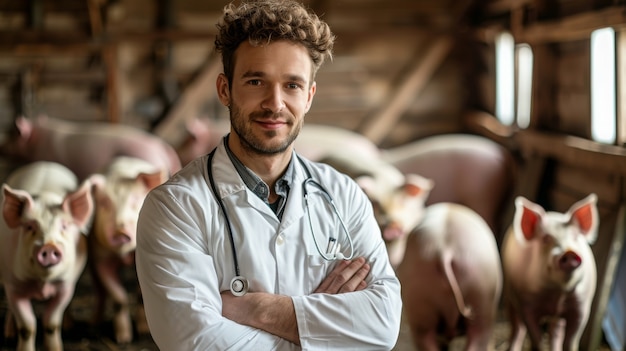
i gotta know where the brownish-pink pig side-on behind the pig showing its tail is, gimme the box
[381,134,514,239]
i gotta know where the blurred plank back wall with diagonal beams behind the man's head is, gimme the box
[0,0,475,150]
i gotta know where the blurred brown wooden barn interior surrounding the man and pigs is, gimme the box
[0,0,626,350]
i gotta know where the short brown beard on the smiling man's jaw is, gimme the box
[230,103,303,156]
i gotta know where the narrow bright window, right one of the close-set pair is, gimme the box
[515,44,533,128]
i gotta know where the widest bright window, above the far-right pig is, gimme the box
[591,28,617,144]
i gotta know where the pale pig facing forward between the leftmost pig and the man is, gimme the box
[88,156,167,343]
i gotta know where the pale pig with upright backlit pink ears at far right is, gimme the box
[502,194,599,351]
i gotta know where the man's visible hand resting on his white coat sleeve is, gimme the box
[314,257,370,294]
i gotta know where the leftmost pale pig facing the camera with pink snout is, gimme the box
[0,162,93,350]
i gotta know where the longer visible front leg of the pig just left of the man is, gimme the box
[96,261,133,344]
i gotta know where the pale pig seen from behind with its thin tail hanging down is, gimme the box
[396,202,502,351]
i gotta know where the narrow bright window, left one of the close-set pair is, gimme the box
[495,32,515,125]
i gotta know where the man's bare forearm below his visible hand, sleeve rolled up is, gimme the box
[222,291,300,345]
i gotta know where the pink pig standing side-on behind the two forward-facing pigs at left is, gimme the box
[0,115,181,180]
